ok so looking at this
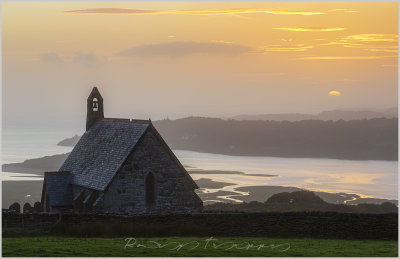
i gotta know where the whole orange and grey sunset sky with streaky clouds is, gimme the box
[2,2,398,129]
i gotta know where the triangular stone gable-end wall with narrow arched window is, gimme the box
[100,130,203,214]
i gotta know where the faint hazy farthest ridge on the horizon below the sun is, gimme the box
[232,108,397,121]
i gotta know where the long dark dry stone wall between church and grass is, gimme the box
[2,212,398,240]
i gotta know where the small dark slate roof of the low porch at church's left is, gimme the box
[44,172,72,206]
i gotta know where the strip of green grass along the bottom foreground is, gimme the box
[3,236,398,257]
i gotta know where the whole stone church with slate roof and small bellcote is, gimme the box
[42,87,203,214]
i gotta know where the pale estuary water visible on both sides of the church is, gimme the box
[2,130,398,199]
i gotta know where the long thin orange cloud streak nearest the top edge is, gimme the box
[64,8,325,15]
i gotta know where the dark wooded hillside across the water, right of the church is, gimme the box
[154,117,398,160]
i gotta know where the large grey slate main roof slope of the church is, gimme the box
[59,119,149,191]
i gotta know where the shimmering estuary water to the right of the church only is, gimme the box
[174,150,398,199]
